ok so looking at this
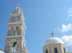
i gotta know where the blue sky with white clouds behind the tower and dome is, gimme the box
[0,0,72,53]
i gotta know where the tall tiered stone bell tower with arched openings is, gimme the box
[5,7,28,53]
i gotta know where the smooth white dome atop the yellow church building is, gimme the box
[45,37,64,46]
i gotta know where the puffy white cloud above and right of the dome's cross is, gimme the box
[54,23,72,32]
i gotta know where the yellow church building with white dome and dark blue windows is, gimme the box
[43,37,67,53]
